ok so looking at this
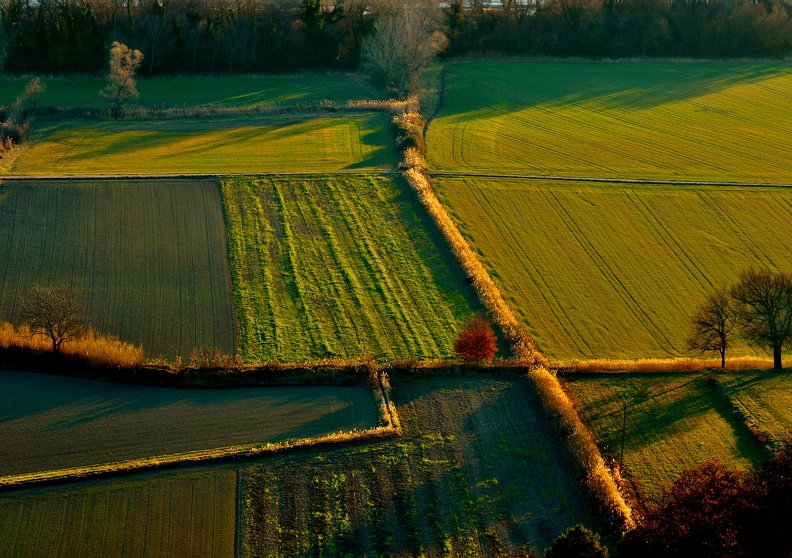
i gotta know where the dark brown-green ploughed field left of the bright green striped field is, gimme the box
[0,180,236,359]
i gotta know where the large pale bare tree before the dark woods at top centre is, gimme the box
[362,2,448,93]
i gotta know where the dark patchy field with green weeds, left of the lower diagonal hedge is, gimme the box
[243,376,596,557]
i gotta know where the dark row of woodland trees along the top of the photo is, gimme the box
[0,0,792,75]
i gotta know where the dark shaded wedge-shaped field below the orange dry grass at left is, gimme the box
[0,371,377,475]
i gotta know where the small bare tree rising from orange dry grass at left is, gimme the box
[22,285,85,353]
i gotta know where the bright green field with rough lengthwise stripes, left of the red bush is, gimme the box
[223,175,477,361]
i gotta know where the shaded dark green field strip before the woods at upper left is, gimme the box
[0,73,376,109]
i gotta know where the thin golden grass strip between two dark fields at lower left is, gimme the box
[0,425,397,491]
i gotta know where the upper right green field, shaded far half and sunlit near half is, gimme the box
[427,62,792,184]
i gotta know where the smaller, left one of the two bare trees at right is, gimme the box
[687,288,737,368]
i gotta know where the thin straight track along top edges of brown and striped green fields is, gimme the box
[0,169,402,185]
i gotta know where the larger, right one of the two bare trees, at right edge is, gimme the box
[731,269,792,370]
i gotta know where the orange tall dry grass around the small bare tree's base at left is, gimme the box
[0,322,145,368]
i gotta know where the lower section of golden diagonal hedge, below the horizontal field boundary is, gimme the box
[528,367,636,531]
